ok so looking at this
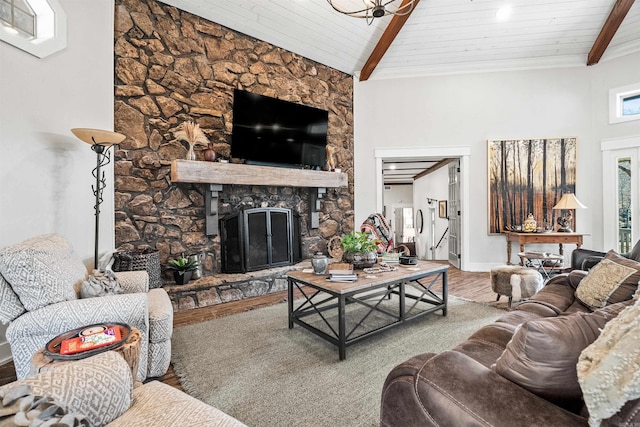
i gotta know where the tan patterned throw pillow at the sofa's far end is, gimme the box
[576,251,640,308]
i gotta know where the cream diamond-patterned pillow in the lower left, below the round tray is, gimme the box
[0,351,133,426]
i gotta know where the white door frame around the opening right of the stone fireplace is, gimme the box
[374,145,471,270]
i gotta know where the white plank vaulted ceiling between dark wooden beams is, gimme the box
[165,0,640,79]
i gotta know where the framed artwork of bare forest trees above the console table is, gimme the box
[487,138,576,234]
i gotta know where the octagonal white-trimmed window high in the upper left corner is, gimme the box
[0,0,67,58]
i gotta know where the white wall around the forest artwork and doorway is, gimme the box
[354,53,640,271]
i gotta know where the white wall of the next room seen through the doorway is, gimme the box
[413,167,449,260]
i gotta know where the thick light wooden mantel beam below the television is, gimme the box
[171,160,347,188]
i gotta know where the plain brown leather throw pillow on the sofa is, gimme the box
[492,301,631,400]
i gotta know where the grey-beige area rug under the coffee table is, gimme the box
[172,297,504,427]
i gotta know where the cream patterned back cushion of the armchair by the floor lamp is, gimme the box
[0,234,87,311]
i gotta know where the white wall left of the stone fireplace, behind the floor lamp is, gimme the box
[0,0,114,360]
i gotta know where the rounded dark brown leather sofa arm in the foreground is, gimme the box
[380,351,586,427]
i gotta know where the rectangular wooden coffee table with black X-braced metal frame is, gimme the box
[287,261,448,360]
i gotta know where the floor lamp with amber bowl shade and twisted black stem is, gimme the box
[71,128,126,270]
